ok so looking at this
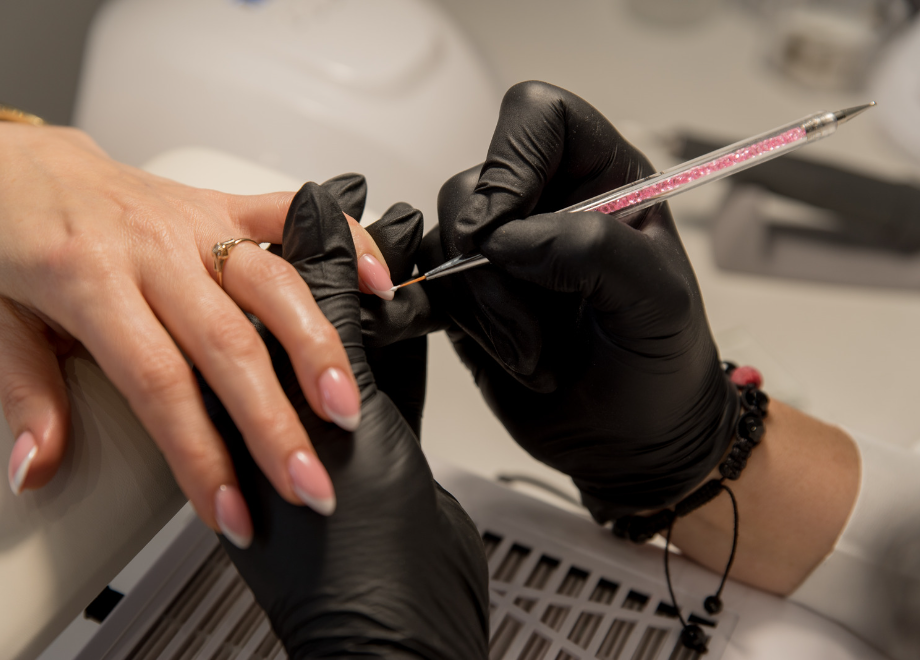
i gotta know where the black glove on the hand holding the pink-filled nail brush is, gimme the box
[413,82,738,521]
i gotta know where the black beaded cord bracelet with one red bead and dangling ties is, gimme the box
[613,362,770,653]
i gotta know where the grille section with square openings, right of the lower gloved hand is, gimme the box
[483,523,737,660]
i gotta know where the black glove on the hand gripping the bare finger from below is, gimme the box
[202,178,488,660]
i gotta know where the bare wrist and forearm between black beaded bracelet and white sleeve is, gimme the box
[671,401,860,596]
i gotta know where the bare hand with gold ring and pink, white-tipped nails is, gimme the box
[0,122,389,541]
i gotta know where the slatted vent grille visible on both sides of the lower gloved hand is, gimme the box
[127,526,737,660]
